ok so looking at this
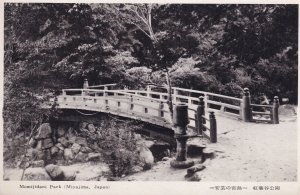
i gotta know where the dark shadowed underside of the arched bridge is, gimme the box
[57,108,176,146]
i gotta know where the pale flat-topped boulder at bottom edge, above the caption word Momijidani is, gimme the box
[23,167,51,181]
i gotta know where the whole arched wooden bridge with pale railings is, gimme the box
[57,82,279,142]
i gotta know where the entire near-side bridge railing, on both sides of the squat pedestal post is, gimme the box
[58,89,216,142]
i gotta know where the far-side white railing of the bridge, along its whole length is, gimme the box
[71,84,279,124]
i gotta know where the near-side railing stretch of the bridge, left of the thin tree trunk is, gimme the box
[58,89,171,126]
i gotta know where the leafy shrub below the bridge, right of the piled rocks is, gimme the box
[97,119,140,177]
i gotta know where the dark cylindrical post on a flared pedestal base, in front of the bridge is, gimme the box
[170,103,194,168]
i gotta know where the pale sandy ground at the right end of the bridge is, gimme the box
[126,112,297,182]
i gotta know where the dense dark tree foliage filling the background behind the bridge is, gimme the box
[3,3,298,158]
